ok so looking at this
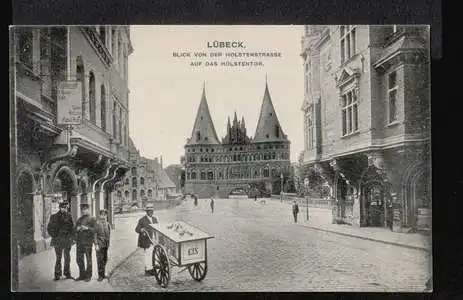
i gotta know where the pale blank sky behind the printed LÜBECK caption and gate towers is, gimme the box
[129,25,303,167]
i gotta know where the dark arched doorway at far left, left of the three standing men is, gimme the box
[18,172,35,255]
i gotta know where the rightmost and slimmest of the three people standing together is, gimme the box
[94,209,111,281]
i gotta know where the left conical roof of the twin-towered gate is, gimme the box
[188,86,220,145]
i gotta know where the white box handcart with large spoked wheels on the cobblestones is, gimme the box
[150,221,213,288]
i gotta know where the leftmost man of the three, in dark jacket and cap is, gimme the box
[47,202,75,281]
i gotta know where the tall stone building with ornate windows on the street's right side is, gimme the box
[301,25,431,231]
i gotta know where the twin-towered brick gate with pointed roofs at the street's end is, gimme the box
[184,83,290,198]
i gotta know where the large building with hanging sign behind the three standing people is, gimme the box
[10,26,133,254]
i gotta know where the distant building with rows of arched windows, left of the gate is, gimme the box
[113,138,175,212]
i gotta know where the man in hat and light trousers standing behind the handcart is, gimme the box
[135,204,158,275]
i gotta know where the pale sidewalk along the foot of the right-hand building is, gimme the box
[299,207,432,252]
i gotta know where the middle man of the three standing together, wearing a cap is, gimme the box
[76,204,96,281]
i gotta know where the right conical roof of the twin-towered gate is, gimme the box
[253,82,287,142]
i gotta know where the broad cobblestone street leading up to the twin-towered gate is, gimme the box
[110,198,431,292]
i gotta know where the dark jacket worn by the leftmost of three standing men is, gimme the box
[47,211,75,248]
